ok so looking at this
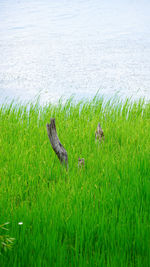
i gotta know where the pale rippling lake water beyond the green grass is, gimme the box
[0,0,150,103]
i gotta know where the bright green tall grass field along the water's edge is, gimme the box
[0,98,150,267]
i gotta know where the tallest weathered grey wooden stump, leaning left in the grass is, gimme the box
[46,118,68,167]
